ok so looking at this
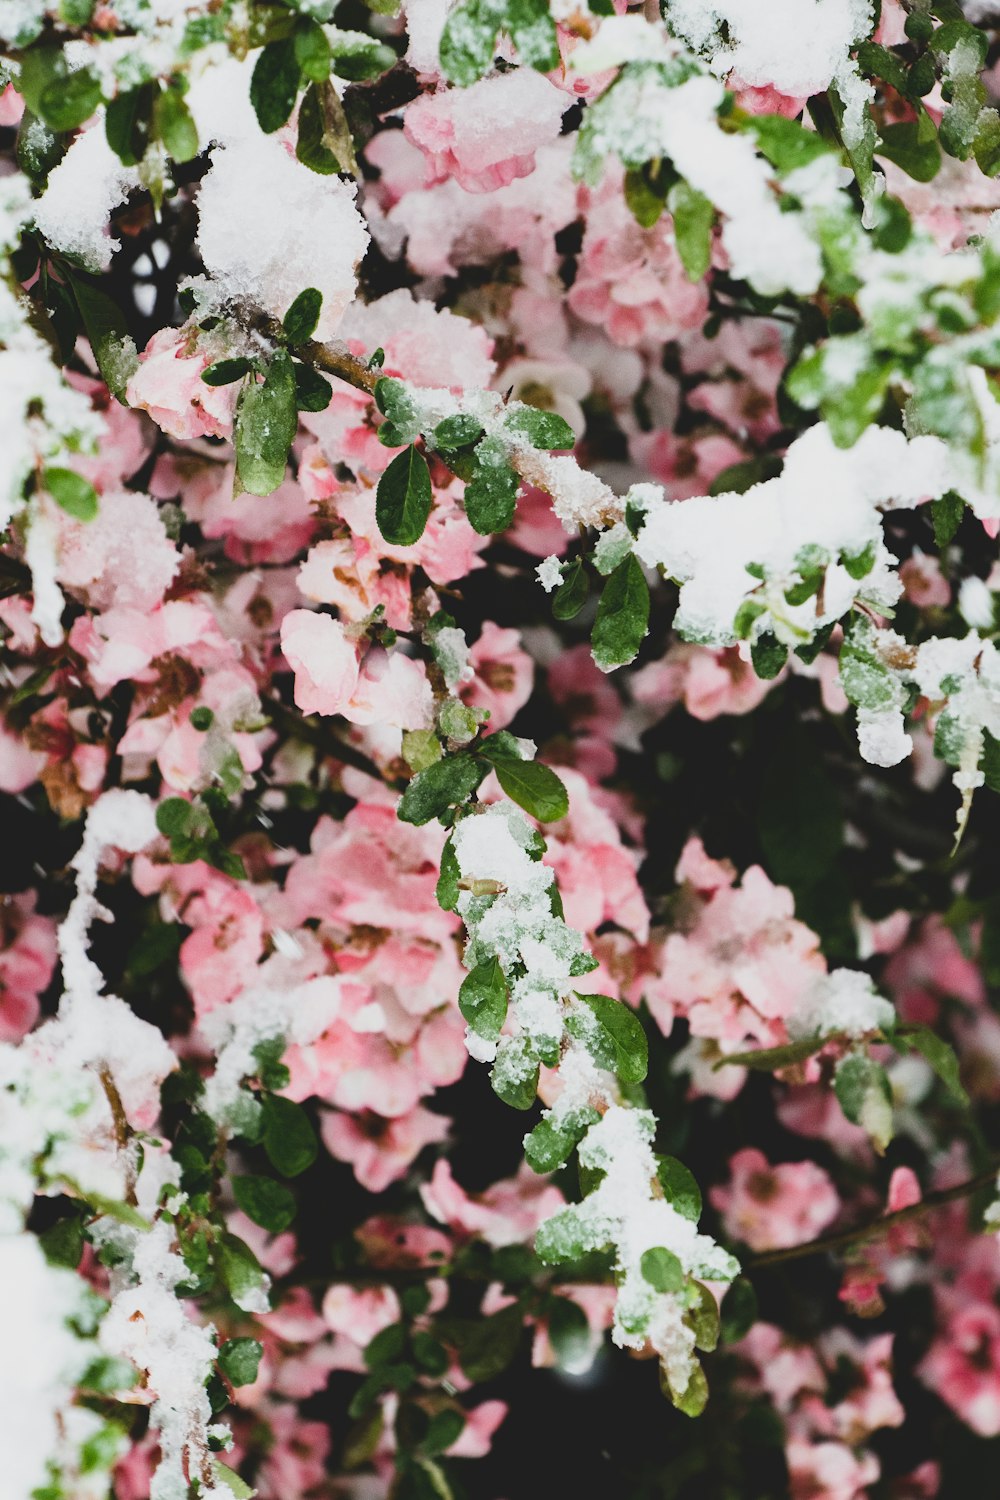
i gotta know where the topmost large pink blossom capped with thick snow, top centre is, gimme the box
[403,68,570,192]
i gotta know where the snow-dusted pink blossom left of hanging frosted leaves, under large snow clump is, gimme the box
[126,329,237,438]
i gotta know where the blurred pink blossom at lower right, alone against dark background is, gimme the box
[711,1146,840,1250]
